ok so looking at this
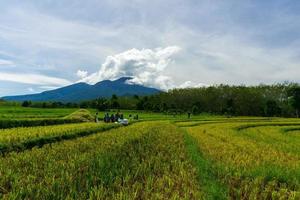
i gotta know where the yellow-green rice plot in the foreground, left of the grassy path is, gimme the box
[0,123,201,199]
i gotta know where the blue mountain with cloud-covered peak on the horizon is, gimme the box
[2,77,160,102]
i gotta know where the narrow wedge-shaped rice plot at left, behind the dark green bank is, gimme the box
[0,123,118,154]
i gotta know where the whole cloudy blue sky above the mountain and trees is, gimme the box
[0,0,300,96]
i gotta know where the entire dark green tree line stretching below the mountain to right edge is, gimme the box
[22,83,300,117]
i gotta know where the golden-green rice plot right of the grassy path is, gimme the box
[181,119,300,199]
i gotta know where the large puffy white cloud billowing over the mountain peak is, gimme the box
[80,46,180,89]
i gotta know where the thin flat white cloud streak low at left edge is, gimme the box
[0,72,71,86]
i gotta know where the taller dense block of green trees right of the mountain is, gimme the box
[141,84,300,117]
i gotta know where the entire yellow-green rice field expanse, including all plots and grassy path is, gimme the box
[0,108,300,200]
